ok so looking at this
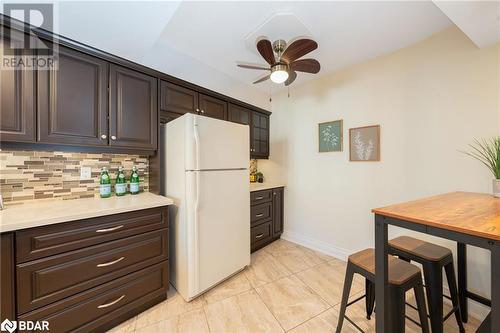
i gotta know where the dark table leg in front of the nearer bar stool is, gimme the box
[375,215,388,333]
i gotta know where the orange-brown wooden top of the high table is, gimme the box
[372,192,500,240]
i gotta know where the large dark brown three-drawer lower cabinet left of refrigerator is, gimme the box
[1,207,169,332]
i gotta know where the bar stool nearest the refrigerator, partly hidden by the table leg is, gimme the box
[336,249,429,333]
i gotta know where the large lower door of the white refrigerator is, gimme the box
[186,170,250,298]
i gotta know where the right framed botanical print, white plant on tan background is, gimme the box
[349,125,380,162]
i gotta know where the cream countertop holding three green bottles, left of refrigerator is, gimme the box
[0,192,173,232]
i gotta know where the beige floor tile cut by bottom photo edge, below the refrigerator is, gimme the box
[136,309,210,333]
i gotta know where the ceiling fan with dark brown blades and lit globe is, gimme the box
[237,38,321,86]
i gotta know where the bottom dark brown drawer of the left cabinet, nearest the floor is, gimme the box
[18,261,168,332]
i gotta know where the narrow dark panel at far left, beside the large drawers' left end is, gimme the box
[0,233,16,321]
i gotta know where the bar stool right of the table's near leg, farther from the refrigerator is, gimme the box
[389,236,465,333]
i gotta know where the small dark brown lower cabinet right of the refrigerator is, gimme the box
[250,187,284,252]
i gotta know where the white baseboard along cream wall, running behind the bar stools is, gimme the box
[281,230,490,320]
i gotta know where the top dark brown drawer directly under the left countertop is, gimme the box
[16,207,168,263]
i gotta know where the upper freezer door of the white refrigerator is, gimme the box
[184,114,250,170]
